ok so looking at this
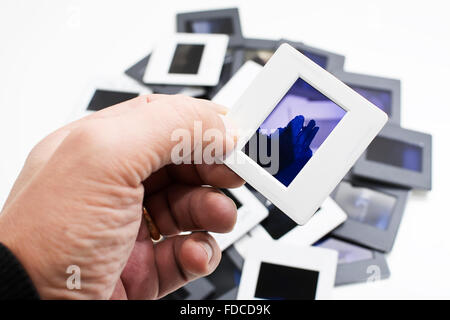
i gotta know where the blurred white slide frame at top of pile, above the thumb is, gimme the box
[143,33,229,86]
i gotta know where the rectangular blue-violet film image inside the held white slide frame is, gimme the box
[243,78,346,187]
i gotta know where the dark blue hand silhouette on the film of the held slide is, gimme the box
[253,115,319,187]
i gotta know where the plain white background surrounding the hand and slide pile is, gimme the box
[0,0,450,299]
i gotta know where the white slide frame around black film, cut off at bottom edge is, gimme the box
[237,241,338,300]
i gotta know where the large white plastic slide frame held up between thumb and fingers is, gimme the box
[224,44,387,225]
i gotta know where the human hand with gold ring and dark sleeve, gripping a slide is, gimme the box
[0,95,243,299]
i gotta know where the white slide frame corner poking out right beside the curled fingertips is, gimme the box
[210,186,269,251]
